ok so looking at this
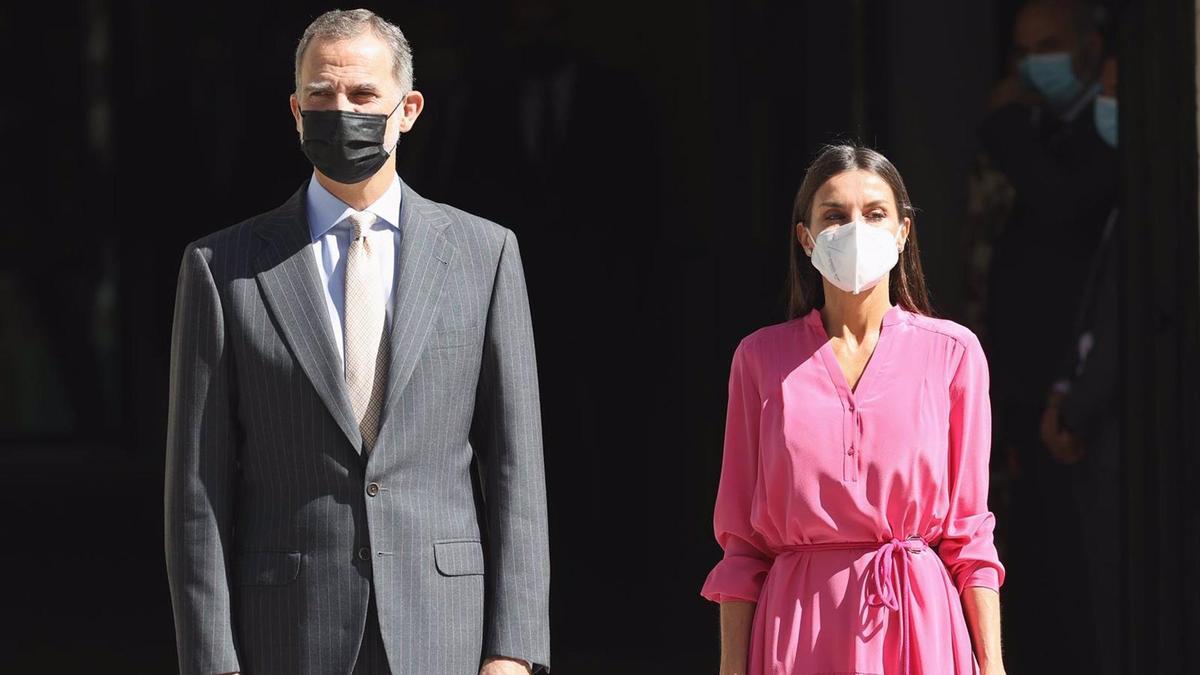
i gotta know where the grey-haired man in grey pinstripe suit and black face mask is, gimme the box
[166,10,550,675]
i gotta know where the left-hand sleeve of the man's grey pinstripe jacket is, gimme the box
[164,246,241,675]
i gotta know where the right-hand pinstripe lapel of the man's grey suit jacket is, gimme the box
[379,184,455,441]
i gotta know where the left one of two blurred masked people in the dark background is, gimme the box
[979,0,1118,669]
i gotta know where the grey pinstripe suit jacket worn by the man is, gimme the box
[166,178,550,675]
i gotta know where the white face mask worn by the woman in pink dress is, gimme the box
[812,220,900,294]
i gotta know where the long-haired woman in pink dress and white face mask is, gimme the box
[702,145,1004,675]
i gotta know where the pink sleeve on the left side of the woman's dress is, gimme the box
[701,340,774,603]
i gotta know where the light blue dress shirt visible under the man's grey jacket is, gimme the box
[306,174,403,363]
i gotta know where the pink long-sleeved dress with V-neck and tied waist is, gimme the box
[702,306,1004,675]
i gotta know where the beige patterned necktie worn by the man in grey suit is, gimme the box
[342,213,390,452]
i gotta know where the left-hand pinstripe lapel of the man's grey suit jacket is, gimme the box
[256,183,362,453]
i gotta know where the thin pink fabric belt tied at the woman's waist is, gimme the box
[780,534,930,675]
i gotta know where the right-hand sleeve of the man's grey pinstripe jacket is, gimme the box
[472,231,550,668]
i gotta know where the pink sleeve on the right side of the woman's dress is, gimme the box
[937,335,1004,593]
